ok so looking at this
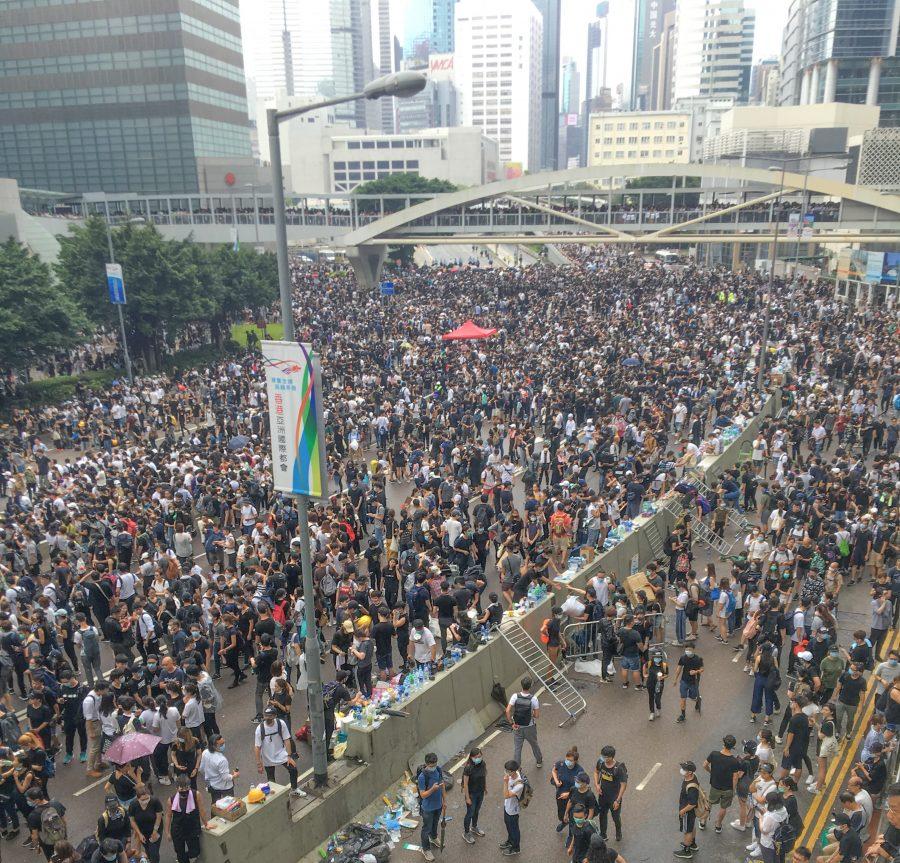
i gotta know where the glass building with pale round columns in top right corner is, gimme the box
[779,0,900,126]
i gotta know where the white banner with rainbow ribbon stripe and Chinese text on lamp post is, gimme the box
[262,341,328,498]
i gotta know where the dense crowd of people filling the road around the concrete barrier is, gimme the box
[0,248,900,863]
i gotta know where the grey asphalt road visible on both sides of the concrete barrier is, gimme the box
[0,438,868,863]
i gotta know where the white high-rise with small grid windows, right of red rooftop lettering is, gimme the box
[454,0,543,173]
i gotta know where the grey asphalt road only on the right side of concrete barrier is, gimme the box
[402,583,880,863]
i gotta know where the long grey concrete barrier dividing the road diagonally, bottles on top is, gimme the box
[203,392,781,863]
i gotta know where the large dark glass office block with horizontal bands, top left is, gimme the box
[0,0,250,193]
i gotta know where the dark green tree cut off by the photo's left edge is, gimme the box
[0,239,87,374]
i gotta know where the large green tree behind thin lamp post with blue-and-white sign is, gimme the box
[56,218,210,371]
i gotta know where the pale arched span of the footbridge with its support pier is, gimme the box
[342,164,900,285]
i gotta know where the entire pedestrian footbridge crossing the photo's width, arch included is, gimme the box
[0,159,900,283]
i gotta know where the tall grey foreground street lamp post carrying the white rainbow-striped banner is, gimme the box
[266,72,427,786]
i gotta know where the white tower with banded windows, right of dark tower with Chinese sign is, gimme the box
[672,0,756,102]
